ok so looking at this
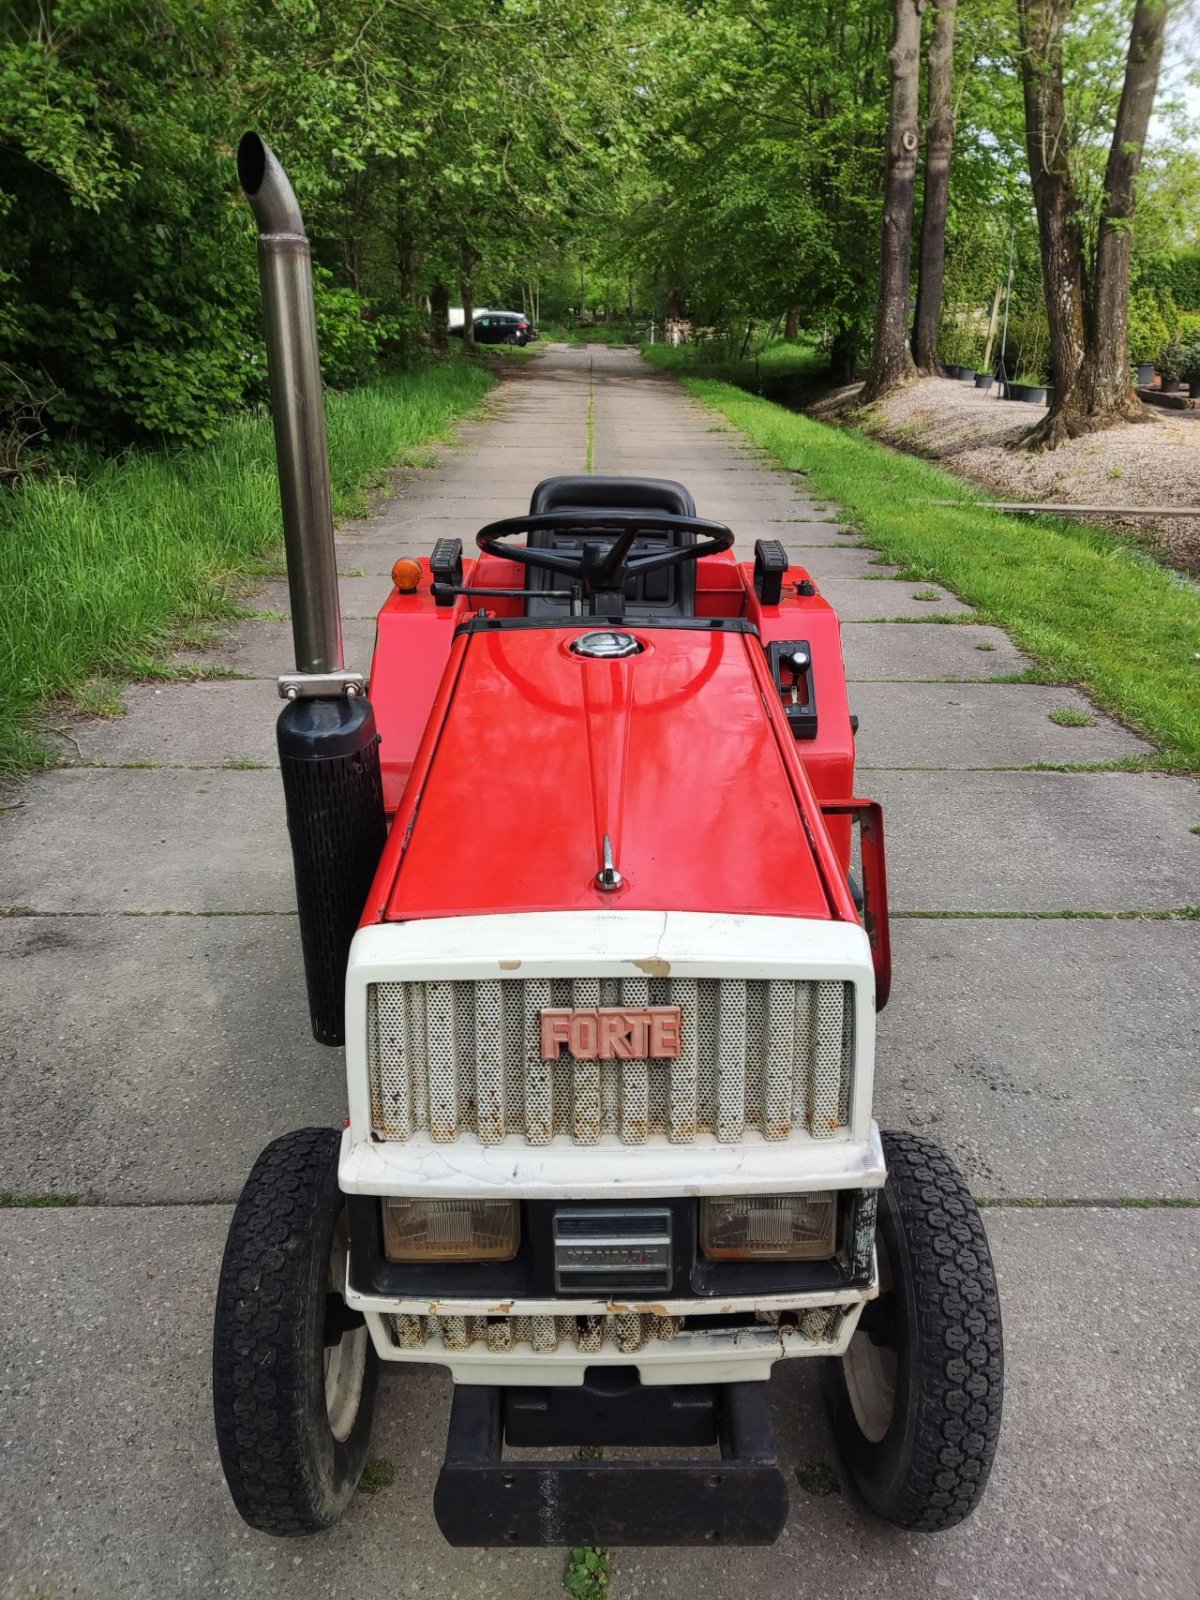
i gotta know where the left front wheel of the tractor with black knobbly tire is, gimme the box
[213,1128,379,1536]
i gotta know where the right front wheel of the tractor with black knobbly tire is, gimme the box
[829,1133,1005,1533]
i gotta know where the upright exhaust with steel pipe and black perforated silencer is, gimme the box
[237,133,387,1045]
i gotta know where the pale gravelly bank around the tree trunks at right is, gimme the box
[814,378,1200,574]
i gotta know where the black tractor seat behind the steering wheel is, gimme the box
[525,477,696,619]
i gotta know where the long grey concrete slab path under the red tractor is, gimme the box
[0,347,1200,1600]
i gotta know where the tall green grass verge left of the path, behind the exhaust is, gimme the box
[0,360,494,771]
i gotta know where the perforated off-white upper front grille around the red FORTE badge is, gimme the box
[368,978,854,1146]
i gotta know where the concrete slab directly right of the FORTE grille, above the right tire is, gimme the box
[875,918,1200,1200]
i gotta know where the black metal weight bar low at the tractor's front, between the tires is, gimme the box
[434,1382,787,1546]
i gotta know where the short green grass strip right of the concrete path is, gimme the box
[686,379,1200,768]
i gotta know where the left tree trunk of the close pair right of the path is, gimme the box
[861,0,925,402]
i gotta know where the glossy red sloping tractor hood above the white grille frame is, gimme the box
[384,622,830,920]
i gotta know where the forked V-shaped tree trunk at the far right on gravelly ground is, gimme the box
[1018,0,1168,450]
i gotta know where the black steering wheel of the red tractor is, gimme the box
[475,510,733,594]
